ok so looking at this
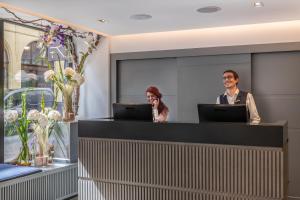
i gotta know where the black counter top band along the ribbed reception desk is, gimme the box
[78,119,287,147]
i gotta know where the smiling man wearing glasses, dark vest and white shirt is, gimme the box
[217,70,260,123]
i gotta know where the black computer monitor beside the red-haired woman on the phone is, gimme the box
[113,103,153,121]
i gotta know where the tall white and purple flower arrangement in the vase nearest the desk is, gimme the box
[40,25,101,121]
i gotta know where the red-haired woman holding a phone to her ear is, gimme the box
[146,86,169,122]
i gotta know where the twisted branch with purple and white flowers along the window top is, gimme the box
[3,7,102,119]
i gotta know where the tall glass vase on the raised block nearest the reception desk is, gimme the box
[63,85,75,122]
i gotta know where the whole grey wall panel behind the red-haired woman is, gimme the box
[117,58,177,121]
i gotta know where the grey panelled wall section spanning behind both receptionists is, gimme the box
[117,54,251,122]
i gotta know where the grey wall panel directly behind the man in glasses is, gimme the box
[177,54,251,122]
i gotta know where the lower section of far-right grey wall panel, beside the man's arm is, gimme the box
[255,95,300,128]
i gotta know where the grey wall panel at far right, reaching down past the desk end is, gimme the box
[252,51,300,196]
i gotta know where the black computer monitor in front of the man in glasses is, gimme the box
[197,104,248,122]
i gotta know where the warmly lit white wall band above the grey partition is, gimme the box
[111,20,300,53]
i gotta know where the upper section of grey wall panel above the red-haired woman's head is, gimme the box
[118,58,177,95]
